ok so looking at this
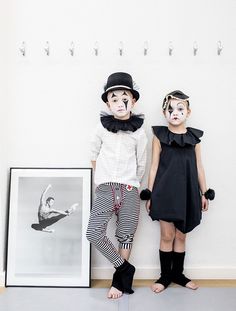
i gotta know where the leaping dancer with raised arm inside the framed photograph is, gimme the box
[31,184,78,233]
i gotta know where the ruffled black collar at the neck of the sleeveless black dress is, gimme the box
[152,126,203,147]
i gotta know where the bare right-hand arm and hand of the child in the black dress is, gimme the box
[195,144,209,211]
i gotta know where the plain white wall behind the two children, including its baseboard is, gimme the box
[0,0,236,284]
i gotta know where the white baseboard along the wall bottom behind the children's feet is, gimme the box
[92,267,236,280]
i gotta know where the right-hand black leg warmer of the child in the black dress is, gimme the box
[172,252,191,286]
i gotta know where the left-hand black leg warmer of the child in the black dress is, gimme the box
[155,250,173,288]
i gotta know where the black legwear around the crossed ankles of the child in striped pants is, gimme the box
[112,260,135,294]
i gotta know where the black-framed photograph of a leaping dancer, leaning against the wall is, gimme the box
[6,168,92,287]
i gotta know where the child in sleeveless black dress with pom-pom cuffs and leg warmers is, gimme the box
[141,91,214,293]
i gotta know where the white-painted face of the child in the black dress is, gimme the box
[164,99,188,125]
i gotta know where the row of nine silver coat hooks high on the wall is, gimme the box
[19,41,223,56]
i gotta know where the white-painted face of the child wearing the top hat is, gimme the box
[107,90,135,120]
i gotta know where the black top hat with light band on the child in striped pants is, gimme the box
[102,72,139,103]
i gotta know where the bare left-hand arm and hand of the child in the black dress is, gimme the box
[146,136,161,213]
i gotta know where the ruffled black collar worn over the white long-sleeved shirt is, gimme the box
[100,112,144,133]
